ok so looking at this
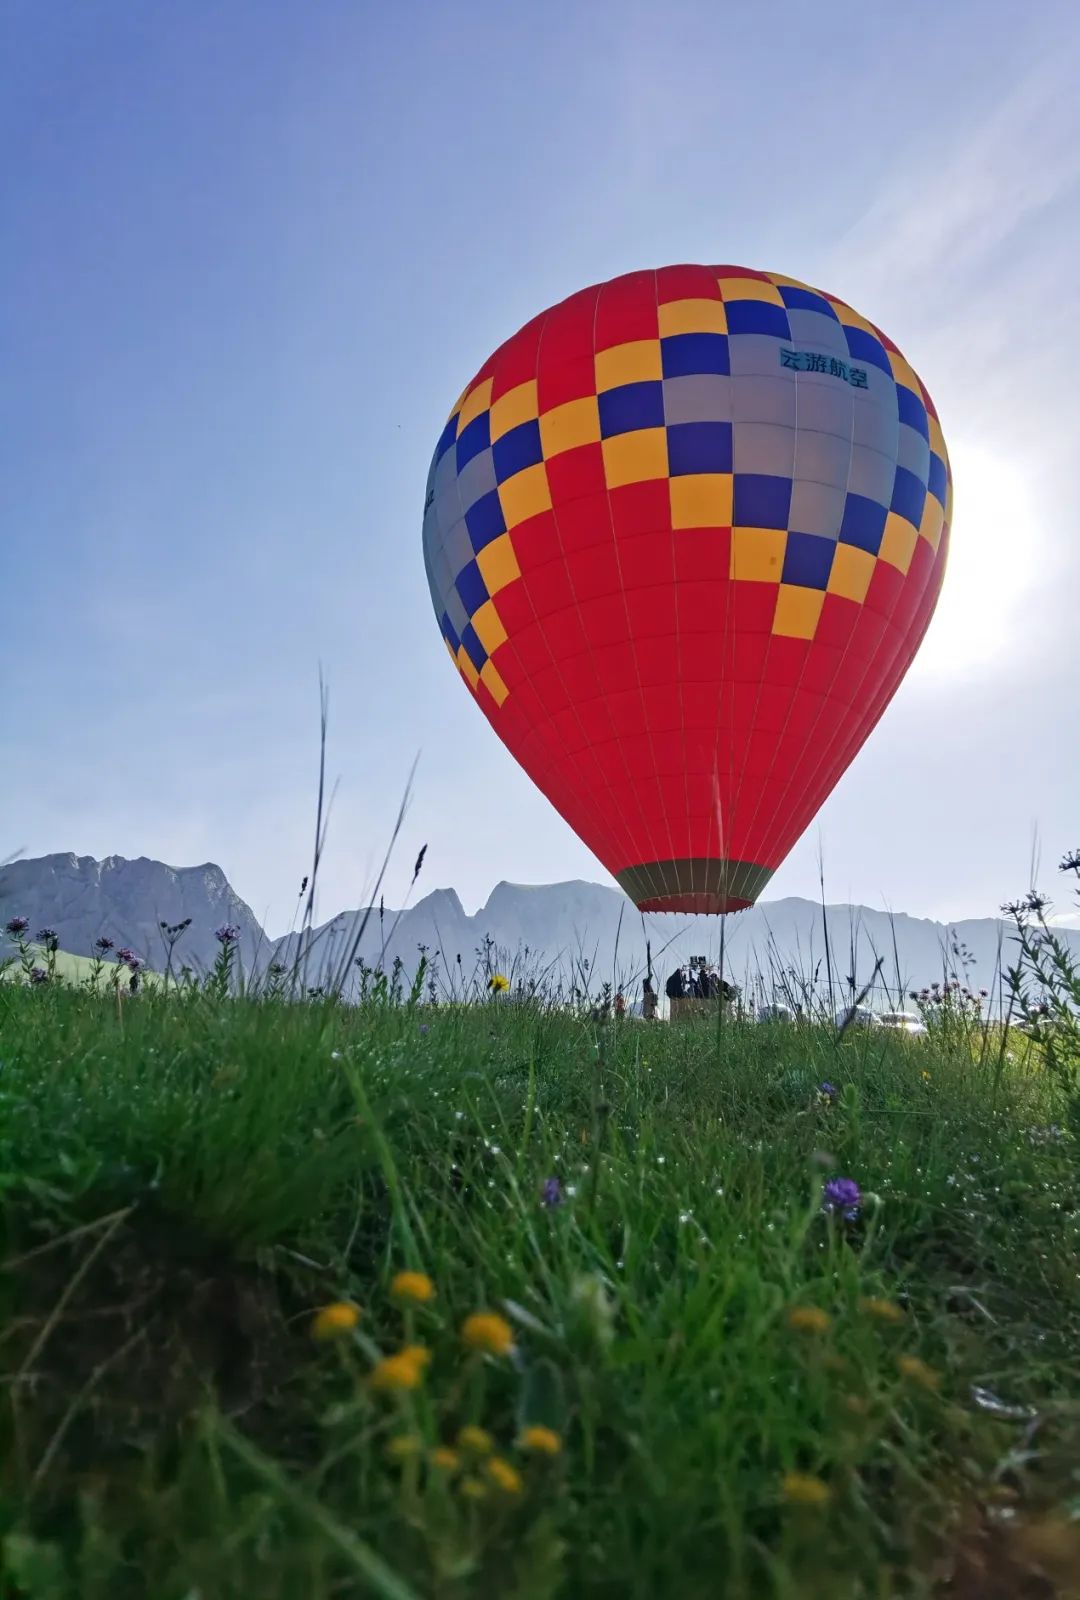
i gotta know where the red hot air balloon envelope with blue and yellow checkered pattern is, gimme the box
[424,266,952,912]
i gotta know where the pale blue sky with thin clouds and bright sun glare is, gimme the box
[0,0,1080,933]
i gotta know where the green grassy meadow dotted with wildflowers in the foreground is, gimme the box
[0,986,1080,1600]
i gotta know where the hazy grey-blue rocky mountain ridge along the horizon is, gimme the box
[0,854,1080,1003]
